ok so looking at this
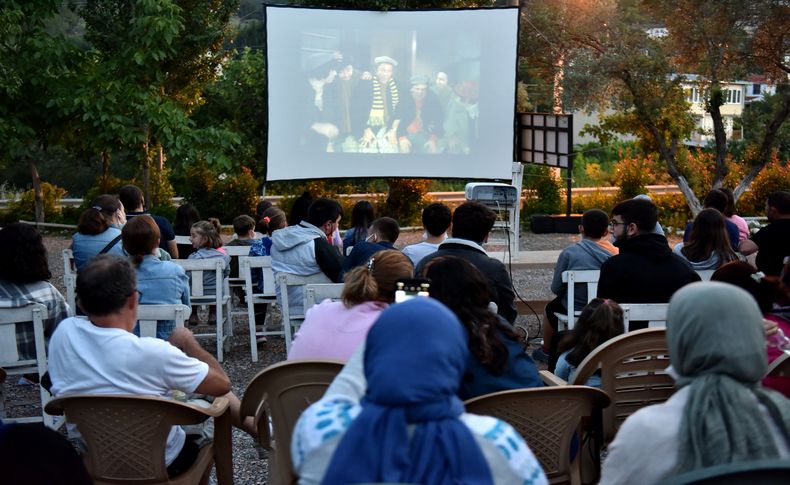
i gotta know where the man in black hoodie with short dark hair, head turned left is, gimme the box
[597,199,700,316]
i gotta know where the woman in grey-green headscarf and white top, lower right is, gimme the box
[600,282,790,484]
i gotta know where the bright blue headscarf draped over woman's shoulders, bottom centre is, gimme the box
[323,298,492,485]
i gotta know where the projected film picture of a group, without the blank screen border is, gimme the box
[298,31,480,154]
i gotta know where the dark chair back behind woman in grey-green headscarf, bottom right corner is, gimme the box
[659,460,790,485]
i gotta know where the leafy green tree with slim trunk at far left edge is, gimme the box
[0,0,78,222]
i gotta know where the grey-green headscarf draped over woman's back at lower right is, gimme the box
[667,282,790,473]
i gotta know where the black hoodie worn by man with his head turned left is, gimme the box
[598,234,700,303]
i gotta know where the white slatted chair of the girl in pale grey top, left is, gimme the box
[173,258,233,362]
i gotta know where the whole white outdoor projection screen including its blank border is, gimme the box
[266,5,518,181]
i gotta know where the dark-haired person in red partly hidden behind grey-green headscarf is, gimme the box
[711,261,790,397]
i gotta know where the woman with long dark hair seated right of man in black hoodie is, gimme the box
[672,209,738,271]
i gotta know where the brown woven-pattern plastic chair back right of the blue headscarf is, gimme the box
[464,386,609,484]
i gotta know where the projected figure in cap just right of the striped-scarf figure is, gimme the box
[392,75,444,153]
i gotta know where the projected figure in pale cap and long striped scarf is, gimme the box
[359,56,399,153]
